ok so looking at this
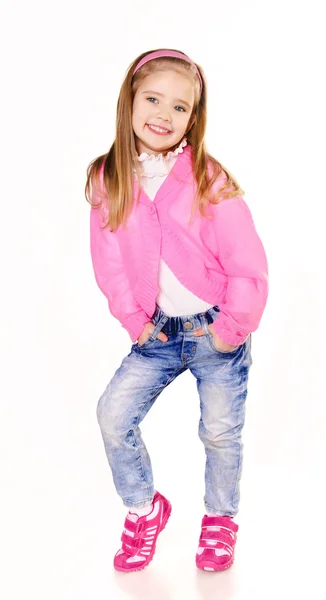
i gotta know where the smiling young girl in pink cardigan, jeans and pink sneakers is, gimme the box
[86,50,268,572]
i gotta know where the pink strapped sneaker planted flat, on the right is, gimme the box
[196,515,239,571]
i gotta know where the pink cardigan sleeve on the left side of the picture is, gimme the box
[90,179,150,342]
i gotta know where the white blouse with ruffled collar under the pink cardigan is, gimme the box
[134,138,212,317]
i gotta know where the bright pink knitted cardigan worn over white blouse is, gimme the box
[90,146,268,346]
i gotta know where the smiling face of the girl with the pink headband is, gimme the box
[132,70,195,155]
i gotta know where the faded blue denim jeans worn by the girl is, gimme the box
[97,306,252,517]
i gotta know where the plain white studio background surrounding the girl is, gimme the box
[0,0,326,600]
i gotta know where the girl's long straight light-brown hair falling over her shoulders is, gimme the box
[85,48,243,231]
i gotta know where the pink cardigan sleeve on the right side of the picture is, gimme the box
[214,197,268,346]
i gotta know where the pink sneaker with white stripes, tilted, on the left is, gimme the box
[113,492,172,573]
